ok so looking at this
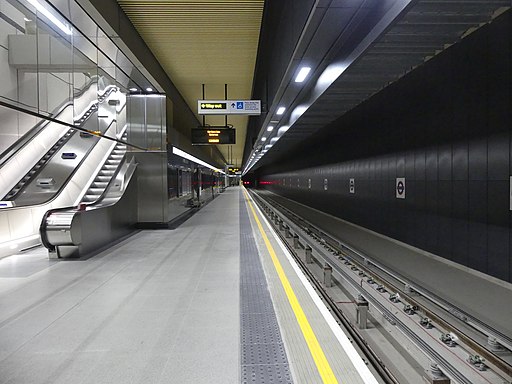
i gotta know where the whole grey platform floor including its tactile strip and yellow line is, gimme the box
[0,188,374,384]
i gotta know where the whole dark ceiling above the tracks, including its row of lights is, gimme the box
[244,0,511,173]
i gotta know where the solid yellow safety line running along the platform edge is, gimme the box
[244,190,338,384]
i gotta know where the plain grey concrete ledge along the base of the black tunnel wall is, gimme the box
[259,191,512,337]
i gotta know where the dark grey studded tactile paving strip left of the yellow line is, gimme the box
[240,192,293,384]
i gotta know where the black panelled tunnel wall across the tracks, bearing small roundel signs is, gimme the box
[258,11,512,282]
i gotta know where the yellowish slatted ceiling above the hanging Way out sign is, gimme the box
[118,0,264,167]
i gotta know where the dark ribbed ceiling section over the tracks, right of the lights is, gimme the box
[246,0,511,169]
